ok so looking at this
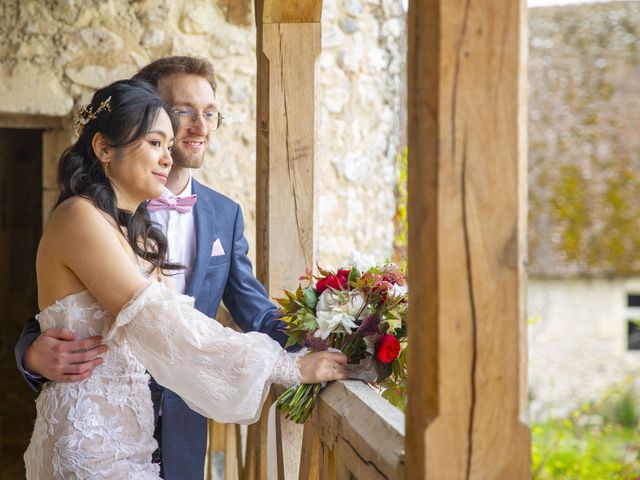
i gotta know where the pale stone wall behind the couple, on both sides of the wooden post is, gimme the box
[0,0,406,273]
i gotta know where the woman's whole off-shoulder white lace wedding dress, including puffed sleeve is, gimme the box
[24,282,300,480]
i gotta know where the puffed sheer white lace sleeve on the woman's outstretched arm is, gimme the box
[103,282,300,423]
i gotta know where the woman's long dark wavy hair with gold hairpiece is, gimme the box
[54,80,182,273]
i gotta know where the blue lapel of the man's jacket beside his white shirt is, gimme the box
[186,180,215,297]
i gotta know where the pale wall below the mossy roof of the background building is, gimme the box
[528,277,640,420]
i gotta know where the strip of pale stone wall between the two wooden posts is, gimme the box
[318,0,406,263]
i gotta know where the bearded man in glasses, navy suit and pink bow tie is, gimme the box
[16,57,286,480]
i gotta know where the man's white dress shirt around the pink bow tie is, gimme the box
[149,176,196,293]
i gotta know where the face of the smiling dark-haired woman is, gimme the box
[106,110,173,212]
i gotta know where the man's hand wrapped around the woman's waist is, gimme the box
[23,328,108,382]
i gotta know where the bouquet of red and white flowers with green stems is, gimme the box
[276,254,408,423]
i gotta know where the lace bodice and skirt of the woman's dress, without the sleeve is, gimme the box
[24,290,160,480]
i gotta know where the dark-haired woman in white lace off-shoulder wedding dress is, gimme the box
[25,80,346,480]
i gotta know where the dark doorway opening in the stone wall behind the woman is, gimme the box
[0,128,43,479]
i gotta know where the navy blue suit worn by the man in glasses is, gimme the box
[15,180,286,480]
